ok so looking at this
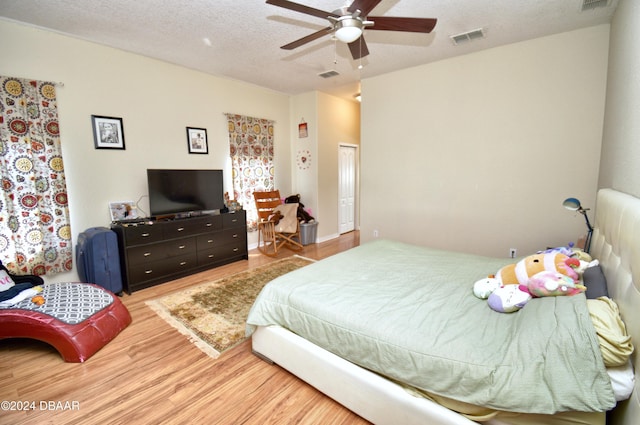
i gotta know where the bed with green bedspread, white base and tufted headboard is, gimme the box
[247,189,640,425]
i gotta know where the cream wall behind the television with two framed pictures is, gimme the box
[0,20,292,281]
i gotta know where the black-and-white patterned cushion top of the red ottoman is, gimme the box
[0,282,113,325]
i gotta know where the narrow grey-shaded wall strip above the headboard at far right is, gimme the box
[598,0,640,196]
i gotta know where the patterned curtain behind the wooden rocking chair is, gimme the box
[226,114,274,230]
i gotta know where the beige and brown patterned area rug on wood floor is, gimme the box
[147,256,313,358]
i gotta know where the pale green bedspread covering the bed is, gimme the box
[247,240,615,414]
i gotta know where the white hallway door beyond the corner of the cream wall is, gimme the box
[338,143,358,234]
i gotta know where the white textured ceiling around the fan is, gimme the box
[0,0,618,98]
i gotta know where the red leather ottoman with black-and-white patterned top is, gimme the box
[0,283,131,363]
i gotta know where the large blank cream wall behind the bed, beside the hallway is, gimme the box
[361,25,609,256]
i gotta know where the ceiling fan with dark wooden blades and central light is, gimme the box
[267,0,438,59]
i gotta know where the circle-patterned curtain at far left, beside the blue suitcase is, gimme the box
[0,76,73,275]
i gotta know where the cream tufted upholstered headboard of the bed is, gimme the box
[590,189,640,425]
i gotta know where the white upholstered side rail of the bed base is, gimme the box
[252,326,476,425]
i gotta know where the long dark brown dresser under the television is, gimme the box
[111,210,249,294]
